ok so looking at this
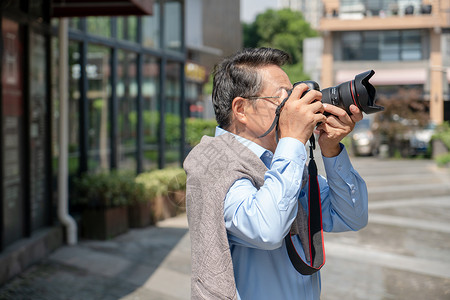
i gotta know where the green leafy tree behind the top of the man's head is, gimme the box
[243,9,318,67]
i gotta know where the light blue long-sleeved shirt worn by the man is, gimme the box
[216,127,368,300]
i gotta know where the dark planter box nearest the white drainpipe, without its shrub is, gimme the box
[81,206,128,240]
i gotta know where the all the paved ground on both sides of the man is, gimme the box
[0,158,450,300]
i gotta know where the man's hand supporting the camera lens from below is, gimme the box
[317,104,363,157]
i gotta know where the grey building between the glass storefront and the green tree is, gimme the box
[186,0,242,119]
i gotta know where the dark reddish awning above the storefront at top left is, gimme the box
[52,0,153,18]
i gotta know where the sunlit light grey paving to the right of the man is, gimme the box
[322,158,450,300]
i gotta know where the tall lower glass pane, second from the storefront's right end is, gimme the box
[142,56,160,171]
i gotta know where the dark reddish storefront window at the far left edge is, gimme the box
[0,18,28,245]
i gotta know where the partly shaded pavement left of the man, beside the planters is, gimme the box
[0,214,191,300]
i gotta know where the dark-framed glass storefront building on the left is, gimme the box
[0,0,187,284]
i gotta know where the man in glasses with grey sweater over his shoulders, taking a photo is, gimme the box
[184,48,367,300]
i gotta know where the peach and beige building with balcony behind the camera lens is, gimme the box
[319,0,450,124]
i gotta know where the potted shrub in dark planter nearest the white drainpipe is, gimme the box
[74,172,134,240]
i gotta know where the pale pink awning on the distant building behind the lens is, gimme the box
[336,68,428,85]
